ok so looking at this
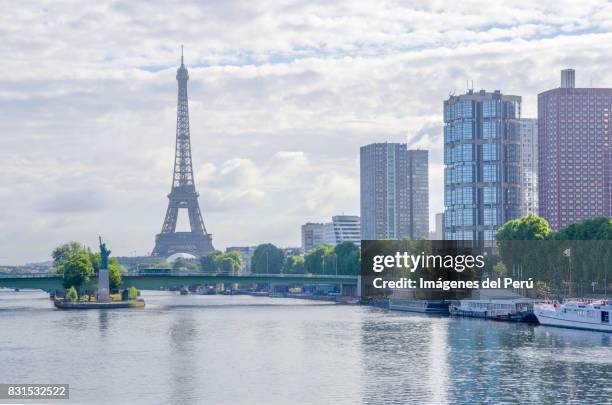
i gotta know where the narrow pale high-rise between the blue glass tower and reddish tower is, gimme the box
[520,118,538,216]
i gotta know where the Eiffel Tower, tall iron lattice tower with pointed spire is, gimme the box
[151,45,214,257]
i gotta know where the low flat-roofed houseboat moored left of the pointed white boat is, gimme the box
[449,298,535,322]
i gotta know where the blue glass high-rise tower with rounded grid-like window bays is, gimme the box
[444,90,521,241]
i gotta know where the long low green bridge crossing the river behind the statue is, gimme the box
[0,272,358,295]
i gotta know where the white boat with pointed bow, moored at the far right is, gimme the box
[533,301,612,332]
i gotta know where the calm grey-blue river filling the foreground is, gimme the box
[0,290,612,405]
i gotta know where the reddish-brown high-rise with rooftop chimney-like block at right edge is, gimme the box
[538,69,612,230]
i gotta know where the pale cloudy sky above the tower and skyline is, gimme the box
[0,0,612,264]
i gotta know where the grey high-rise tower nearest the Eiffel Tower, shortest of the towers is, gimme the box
[360,143,429,240]
